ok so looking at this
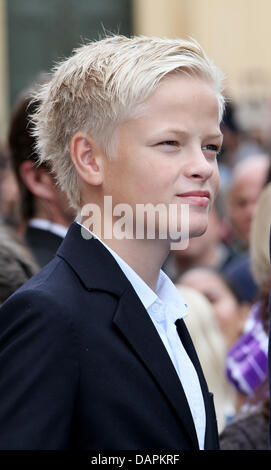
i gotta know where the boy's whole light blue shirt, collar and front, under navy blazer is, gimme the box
[76,224,206,450]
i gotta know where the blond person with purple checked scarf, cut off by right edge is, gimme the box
[220,183,271,450]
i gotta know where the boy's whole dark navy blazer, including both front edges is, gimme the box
[0,223,218,450]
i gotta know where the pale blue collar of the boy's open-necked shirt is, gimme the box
[77,221,187,323]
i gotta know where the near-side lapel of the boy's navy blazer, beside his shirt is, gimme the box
[113,286,198,449]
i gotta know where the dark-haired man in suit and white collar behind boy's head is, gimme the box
[8,86,74,267]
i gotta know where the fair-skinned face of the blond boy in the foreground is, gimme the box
[103,74,222,242]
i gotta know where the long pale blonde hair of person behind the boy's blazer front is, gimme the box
[176,284,236,432]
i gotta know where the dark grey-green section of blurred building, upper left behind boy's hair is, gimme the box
[0,0,132,140]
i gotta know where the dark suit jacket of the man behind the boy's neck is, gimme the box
[25,226,63,268]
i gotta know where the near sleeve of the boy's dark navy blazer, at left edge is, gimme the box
[0,290,78,450]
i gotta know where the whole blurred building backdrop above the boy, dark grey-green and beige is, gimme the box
[0,0,271,139]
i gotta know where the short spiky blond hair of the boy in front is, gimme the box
[33,36,224,209]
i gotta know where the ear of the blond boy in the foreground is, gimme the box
[70,132,103,186]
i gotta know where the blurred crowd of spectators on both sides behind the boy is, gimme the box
[0,77,271,449]
